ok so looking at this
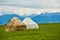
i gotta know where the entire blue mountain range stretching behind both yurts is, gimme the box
[0,12,60,24]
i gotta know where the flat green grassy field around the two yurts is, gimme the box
[0,23,60,40]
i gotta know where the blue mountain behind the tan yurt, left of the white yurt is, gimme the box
[0,14,24,24]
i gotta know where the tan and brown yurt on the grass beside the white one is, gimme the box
[5,17,26,31]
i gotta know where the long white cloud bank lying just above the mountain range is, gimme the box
[0,6,60,16]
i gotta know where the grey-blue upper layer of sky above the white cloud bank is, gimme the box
[0,0,60,9]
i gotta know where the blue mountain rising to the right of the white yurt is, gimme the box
[31,12,60,23]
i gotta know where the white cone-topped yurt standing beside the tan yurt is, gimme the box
[23,17,39,29]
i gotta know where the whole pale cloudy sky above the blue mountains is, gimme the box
[0,0,60,16]
